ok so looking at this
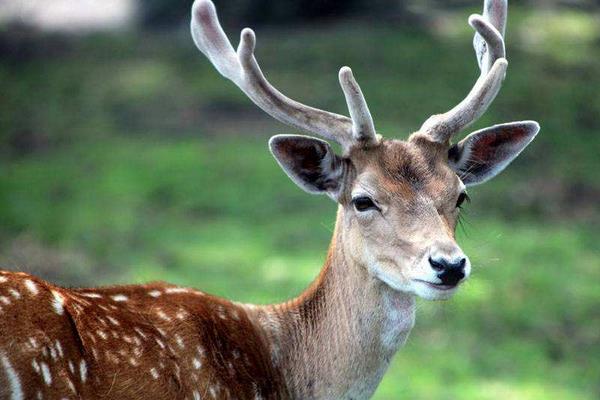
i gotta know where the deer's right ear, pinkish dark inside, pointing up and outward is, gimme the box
[448,121,540,186]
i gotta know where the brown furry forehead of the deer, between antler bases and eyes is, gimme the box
[349,140,463,203]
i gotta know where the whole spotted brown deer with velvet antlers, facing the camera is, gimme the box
[0,0,540,400]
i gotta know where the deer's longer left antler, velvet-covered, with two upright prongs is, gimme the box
[191,0,378,148]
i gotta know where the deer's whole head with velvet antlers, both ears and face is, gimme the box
[191,0,539,299]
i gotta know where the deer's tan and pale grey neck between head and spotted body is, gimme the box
[251,209,415,399]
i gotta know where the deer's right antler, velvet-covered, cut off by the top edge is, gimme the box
[420,0,508,143]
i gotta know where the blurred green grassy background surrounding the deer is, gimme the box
[0,0,600,400]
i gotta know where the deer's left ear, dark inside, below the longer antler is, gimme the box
[269,135,346,200]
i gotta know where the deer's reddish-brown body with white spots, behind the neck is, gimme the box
[0,272,281,400]
